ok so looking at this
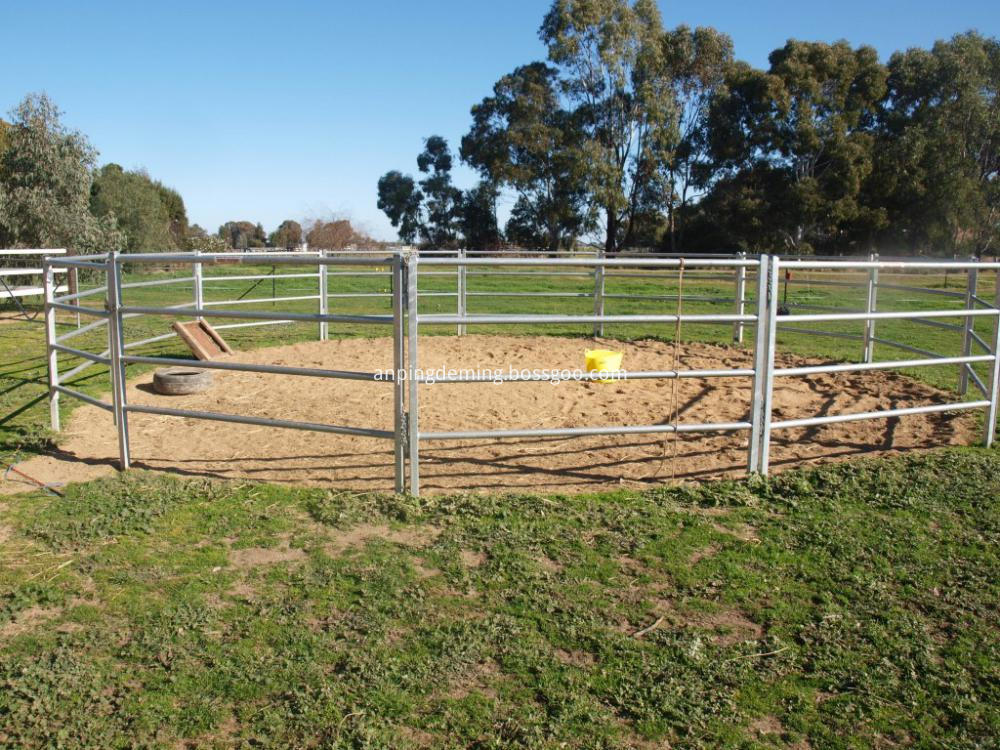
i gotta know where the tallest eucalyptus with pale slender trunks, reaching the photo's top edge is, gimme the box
[539,0,673,252]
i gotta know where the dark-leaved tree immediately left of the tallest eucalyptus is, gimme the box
[461,62,592,252]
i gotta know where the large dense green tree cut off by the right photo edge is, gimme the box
[870,32,1000,253]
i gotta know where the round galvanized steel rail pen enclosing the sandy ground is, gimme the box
[41,250,1000,495]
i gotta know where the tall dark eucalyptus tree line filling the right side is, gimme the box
[378,0,1000,254]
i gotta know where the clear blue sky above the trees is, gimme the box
[0,0,1000,239]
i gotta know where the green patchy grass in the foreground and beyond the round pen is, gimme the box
[0,258,1000,750]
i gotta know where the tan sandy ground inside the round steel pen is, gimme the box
[5,336,978,492]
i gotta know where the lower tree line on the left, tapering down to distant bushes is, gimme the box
[0,94,371,253]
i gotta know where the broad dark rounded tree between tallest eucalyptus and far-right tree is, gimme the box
[711,41,886,253]
